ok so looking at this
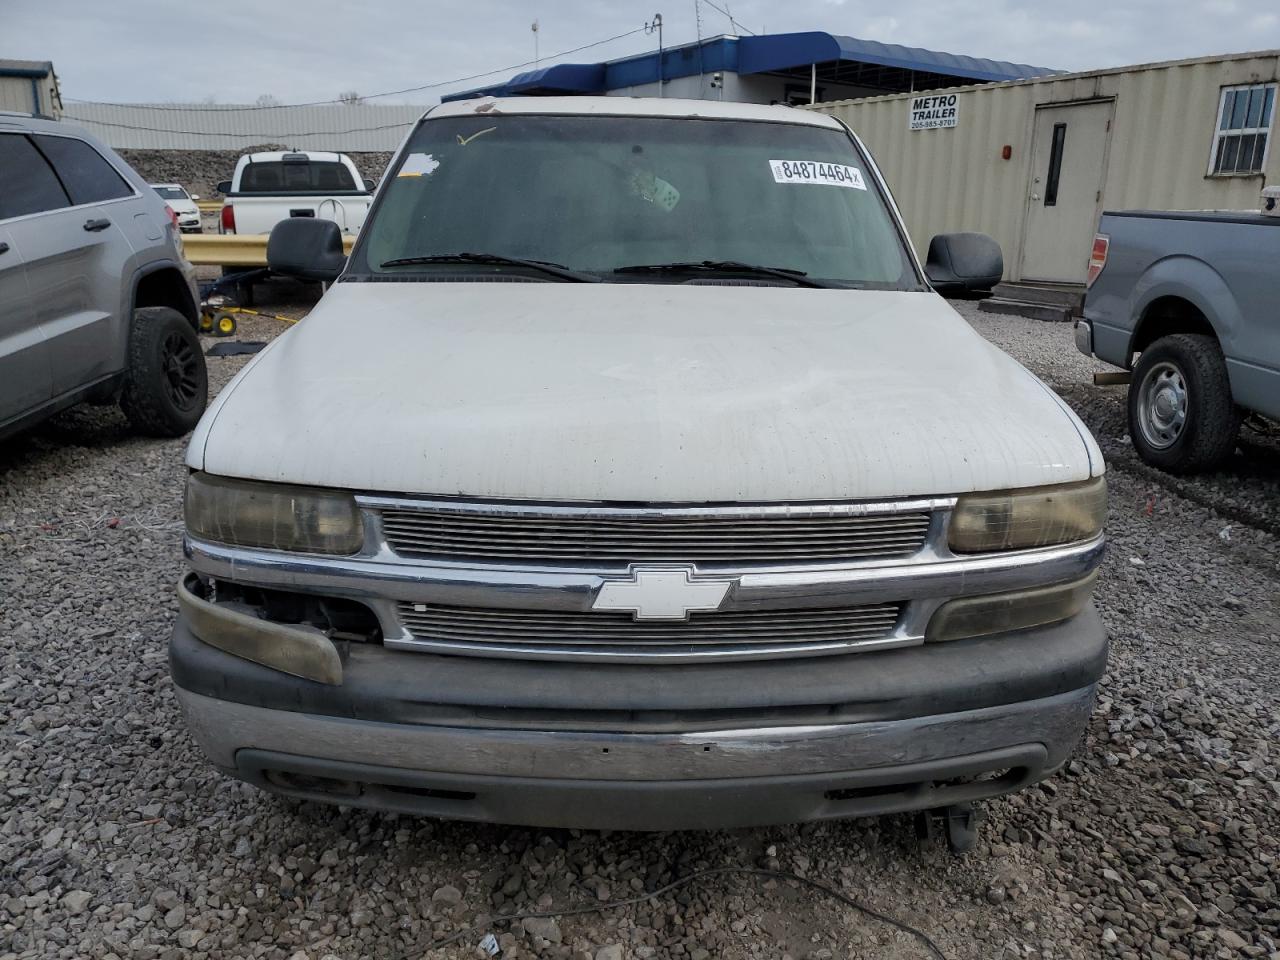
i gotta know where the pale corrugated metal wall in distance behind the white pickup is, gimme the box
[63,102,429,152]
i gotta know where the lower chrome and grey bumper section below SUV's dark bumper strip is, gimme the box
[177,619,1094,829]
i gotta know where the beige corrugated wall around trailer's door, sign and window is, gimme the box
[814,51,1280,280]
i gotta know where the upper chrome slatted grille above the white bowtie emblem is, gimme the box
[381,500,932,564]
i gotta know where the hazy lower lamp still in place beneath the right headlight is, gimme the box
[924,571,1098,643]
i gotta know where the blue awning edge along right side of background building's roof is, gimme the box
[737,32,1059,82]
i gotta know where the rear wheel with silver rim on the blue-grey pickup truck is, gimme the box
[1129,333,1240,474]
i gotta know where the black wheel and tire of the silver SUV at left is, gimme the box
[120,307,209,436]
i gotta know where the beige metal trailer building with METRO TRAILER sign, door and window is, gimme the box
[813,50,1280,284]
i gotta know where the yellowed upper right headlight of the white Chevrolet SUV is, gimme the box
[948,476,1107,553]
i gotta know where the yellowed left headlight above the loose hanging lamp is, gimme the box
[186,474,365,554]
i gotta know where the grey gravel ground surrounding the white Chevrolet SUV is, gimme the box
[0,289,1280,960]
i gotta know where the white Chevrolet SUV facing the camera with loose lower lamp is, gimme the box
[170,97,1107,847]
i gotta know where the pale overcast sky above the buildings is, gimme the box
[0,0,1280,104]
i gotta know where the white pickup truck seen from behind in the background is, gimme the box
[218,151,374,239]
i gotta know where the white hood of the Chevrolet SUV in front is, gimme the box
[188,282,1103,503]
